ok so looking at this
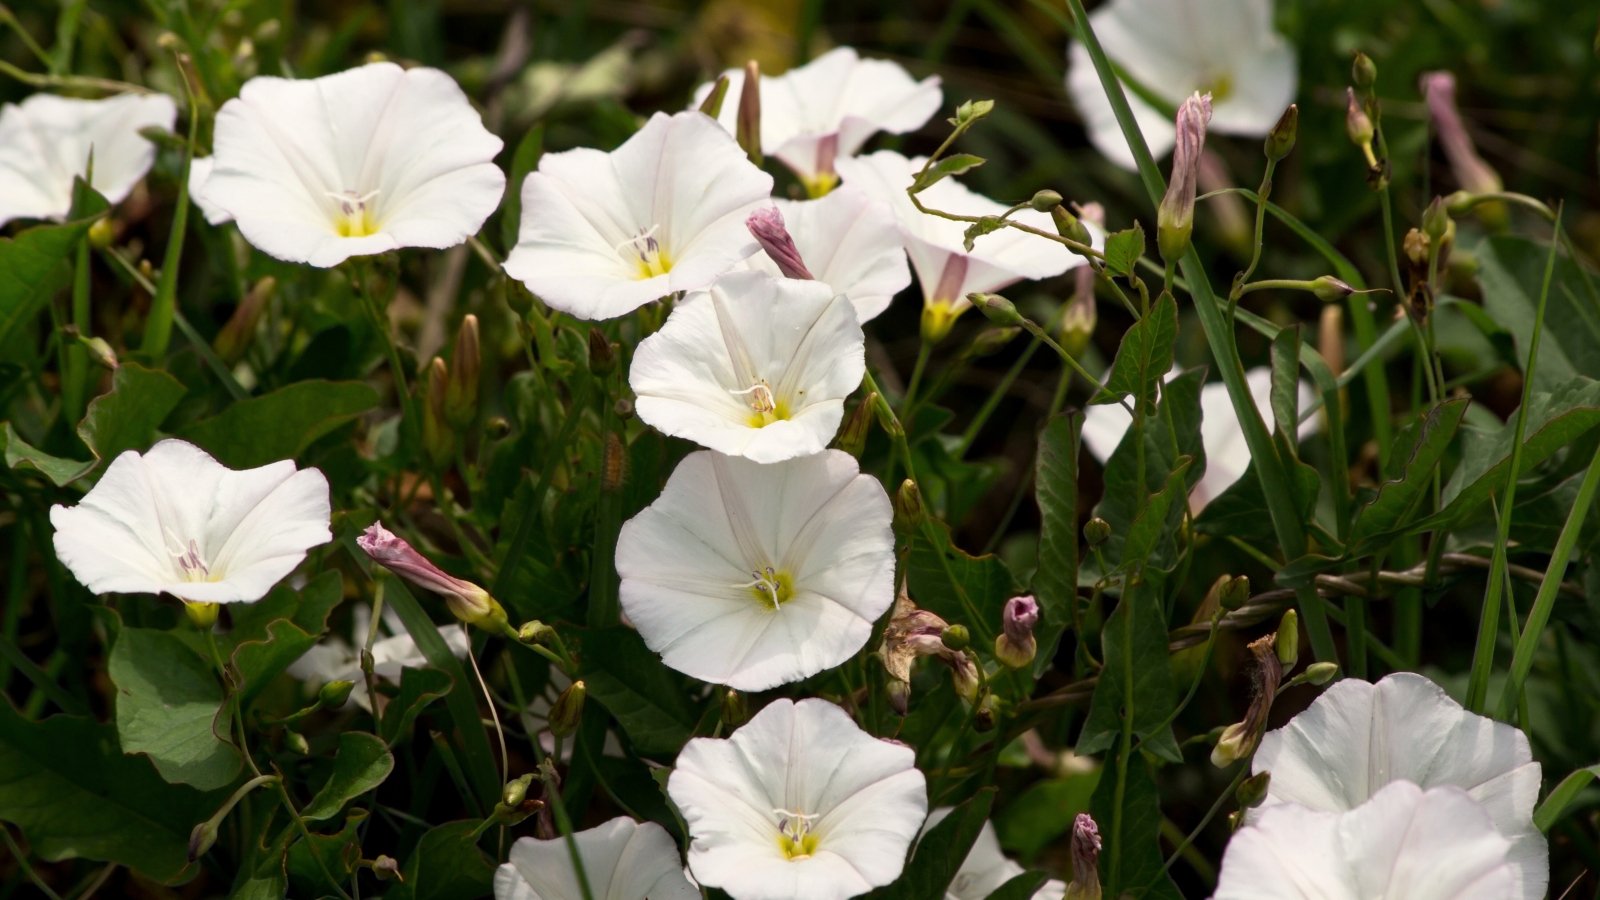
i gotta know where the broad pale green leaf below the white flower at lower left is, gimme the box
[107,628,243,791]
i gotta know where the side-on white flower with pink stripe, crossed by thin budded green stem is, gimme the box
[838,151,1101,338]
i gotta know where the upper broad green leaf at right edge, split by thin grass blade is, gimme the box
[1477,235,1600,391]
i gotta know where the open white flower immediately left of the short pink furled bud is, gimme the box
[506,112,773,319]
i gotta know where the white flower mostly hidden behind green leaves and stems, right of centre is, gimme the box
[1083,367,1318,514]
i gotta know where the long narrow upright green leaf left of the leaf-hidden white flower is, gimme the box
[1034,415,1082,676]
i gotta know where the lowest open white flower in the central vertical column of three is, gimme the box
[667,700,928,900]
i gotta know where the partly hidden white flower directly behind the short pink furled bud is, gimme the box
[749,186,910,322]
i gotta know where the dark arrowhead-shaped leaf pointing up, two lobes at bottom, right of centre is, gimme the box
[1077,577,1182,755]
